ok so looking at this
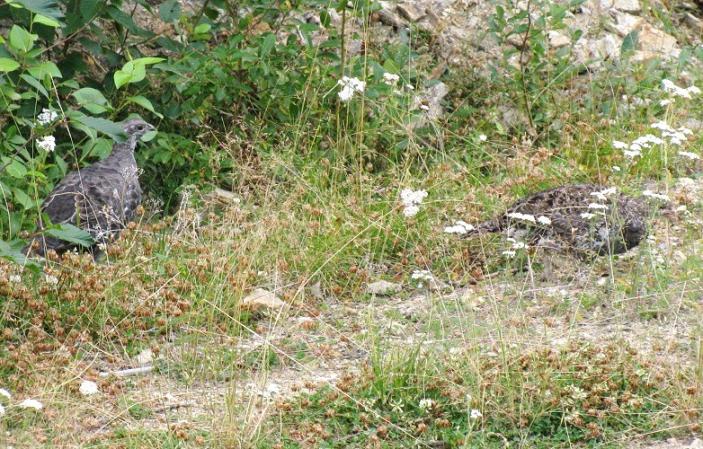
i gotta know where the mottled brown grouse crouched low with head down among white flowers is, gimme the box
[465,184,648,256]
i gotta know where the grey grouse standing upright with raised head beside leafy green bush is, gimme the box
[23,119,155,256]
